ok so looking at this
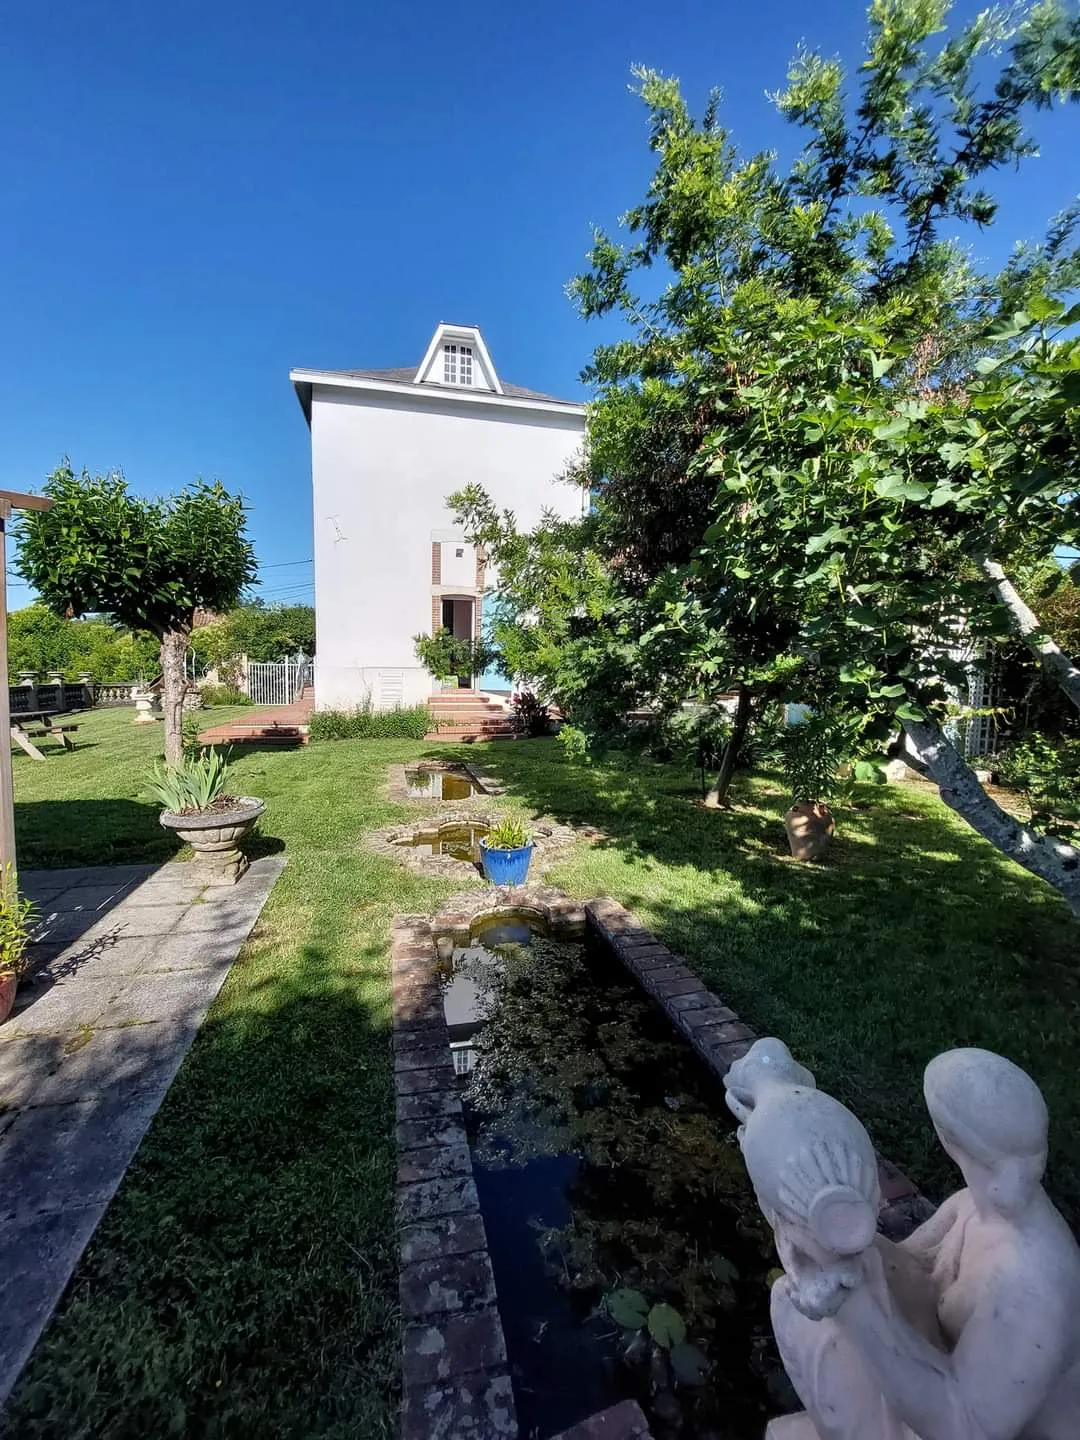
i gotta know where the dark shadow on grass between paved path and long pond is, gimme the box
[0,917,399,1440]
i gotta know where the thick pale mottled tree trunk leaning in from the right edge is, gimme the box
[903,719,1080,916]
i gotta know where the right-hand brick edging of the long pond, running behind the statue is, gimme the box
[585,899,933,1240]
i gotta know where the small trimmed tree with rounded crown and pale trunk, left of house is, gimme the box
[16,462,255,765]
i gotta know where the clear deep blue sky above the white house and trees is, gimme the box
[0,0,1080,605]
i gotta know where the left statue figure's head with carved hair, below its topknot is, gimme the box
[740,1084,881,1319]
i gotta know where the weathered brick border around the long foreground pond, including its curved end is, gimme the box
[390,887,933,1440]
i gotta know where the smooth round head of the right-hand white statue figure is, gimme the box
[923,1050,1050,1220]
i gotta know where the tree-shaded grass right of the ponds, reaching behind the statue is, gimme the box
[466,742,1080,1224]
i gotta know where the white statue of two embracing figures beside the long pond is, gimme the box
[724,1040,1080,1440]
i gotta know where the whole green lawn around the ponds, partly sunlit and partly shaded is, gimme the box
[4,711,1080,1440]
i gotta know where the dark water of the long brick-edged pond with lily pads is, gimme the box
[442,922,798,1440]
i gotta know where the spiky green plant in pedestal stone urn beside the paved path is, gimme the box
[153,747,266,886]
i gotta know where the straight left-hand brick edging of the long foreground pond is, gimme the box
[390,916,517,1440]
